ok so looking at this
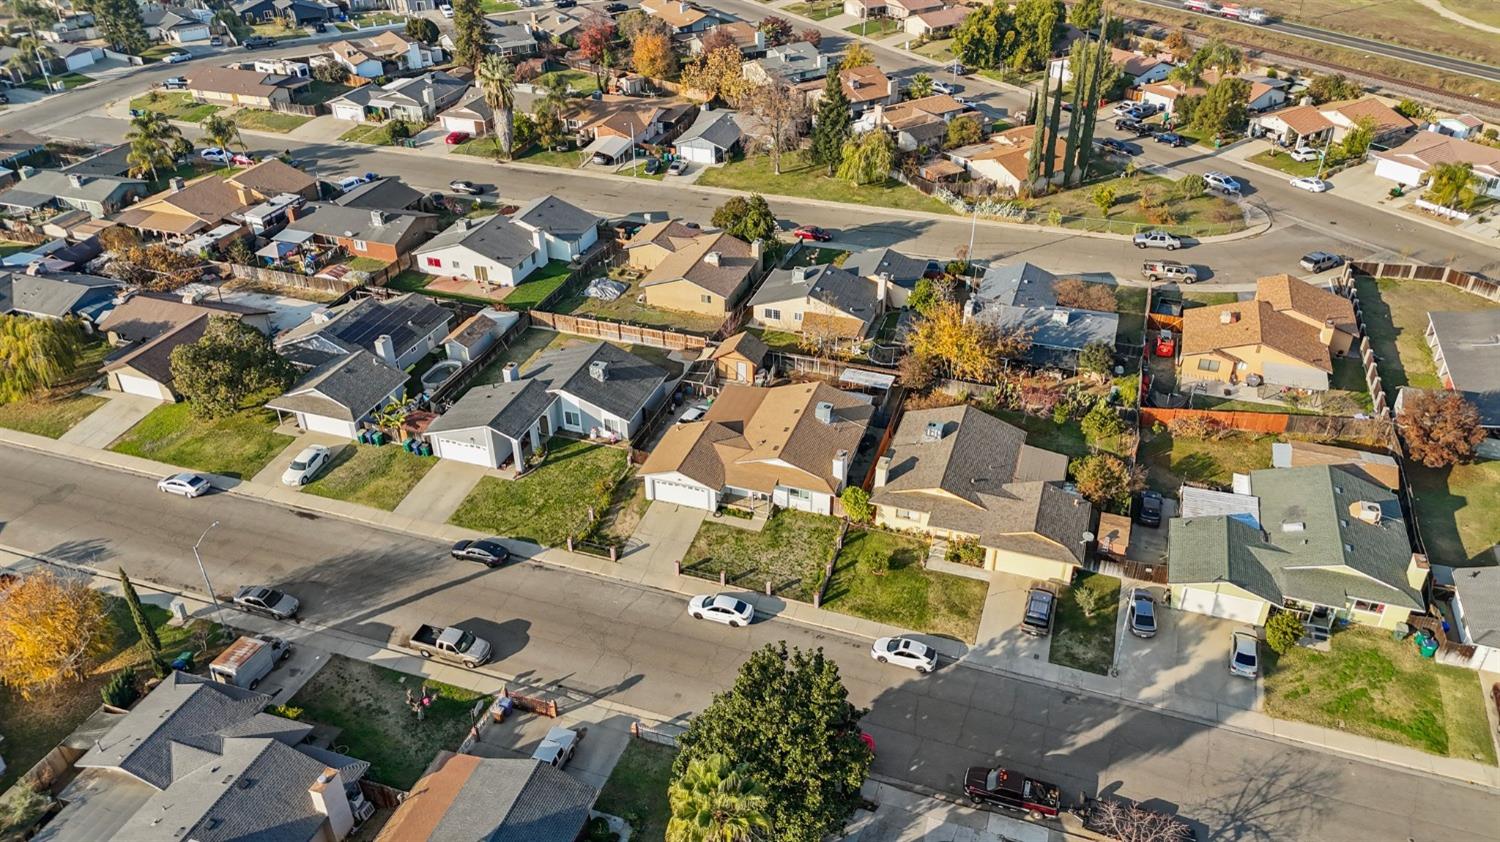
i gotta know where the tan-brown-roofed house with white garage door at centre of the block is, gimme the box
[641,383,875,515]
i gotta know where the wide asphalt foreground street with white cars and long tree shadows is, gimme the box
[0,447,1500,842]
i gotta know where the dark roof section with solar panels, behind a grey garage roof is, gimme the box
[276,293,453,371]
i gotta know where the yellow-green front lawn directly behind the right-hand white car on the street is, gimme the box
[824,530,989,642]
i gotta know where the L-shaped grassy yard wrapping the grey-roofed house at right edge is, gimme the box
[1355,278,1500,395]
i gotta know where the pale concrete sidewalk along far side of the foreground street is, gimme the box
[0,420,1500,789]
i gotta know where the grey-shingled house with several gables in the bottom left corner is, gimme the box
[36,671,374,842]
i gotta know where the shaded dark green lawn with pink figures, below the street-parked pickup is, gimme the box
[285,654,488,789]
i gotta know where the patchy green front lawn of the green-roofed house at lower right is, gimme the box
[1265,627,1496,765]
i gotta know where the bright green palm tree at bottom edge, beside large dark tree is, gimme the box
[666,755,771,842]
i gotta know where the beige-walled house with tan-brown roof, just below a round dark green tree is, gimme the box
[639,231,762,318]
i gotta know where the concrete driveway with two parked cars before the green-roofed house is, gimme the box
[1116,587,1262,716]
